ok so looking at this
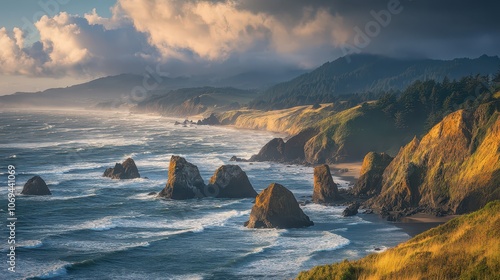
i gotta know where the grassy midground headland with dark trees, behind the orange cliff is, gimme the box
[231,76,496,164]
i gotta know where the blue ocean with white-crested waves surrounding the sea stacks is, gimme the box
[0,110,409,279]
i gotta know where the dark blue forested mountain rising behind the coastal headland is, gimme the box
[252,54,500,109]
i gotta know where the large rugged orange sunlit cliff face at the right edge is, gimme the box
[369,101,500,214]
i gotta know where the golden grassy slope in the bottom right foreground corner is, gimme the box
[297,200,500,280]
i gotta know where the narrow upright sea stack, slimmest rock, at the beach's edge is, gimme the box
[312,164,342,203]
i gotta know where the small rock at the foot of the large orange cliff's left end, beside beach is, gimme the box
[352,152,393,196]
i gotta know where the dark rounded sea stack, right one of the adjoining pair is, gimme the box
[208,165,257,198]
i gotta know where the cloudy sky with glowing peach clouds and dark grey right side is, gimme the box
[0,0,500,95]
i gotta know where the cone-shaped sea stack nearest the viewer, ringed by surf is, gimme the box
[245,183,314,228]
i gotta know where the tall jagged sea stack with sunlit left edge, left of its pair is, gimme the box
[158,156,205,199]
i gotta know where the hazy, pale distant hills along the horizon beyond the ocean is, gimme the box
[0,70,303,109]
